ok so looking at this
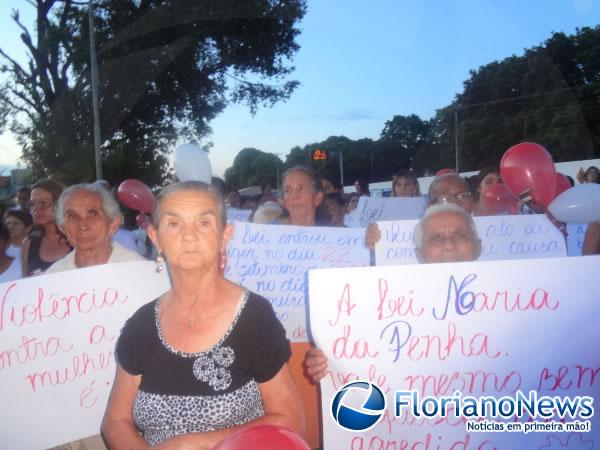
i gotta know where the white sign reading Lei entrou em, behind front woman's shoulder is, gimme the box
[225,223,369,342]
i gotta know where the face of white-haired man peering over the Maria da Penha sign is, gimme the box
[417,211,481,263]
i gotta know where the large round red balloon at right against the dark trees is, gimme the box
[500,142,556,207]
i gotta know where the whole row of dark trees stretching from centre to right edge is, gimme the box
[225,26,600,185]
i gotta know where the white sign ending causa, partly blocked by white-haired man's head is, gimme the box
[375,214,567,266]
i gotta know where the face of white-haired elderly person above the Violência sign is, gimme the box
[62,191,120,251]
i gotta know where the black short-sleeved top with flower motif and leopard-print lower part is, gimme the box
[116,291,290,446]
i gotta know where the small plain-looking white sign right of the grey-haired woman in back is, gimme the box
[344,197,426,228]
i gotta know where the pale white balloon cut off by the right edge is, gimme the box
[548,183,600,223]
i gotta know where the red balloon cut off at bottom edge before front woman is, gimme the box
[213,425,310,450]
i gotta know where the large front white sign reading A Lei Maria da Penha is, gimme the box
[309,256,600,450]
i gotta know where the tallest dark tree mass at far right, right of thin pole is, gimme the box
[450,27,600,170]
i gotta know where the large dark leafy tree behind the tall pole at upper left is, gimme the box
[0,0,306,185]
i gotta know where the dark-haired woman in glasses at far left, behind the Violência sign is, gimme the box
[21,180,71,276]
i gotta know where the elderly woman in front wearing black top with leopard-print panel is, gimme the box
[102,182,304,449]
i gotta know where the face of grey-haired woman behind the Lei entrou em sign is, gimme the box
[283,172,323,225]
